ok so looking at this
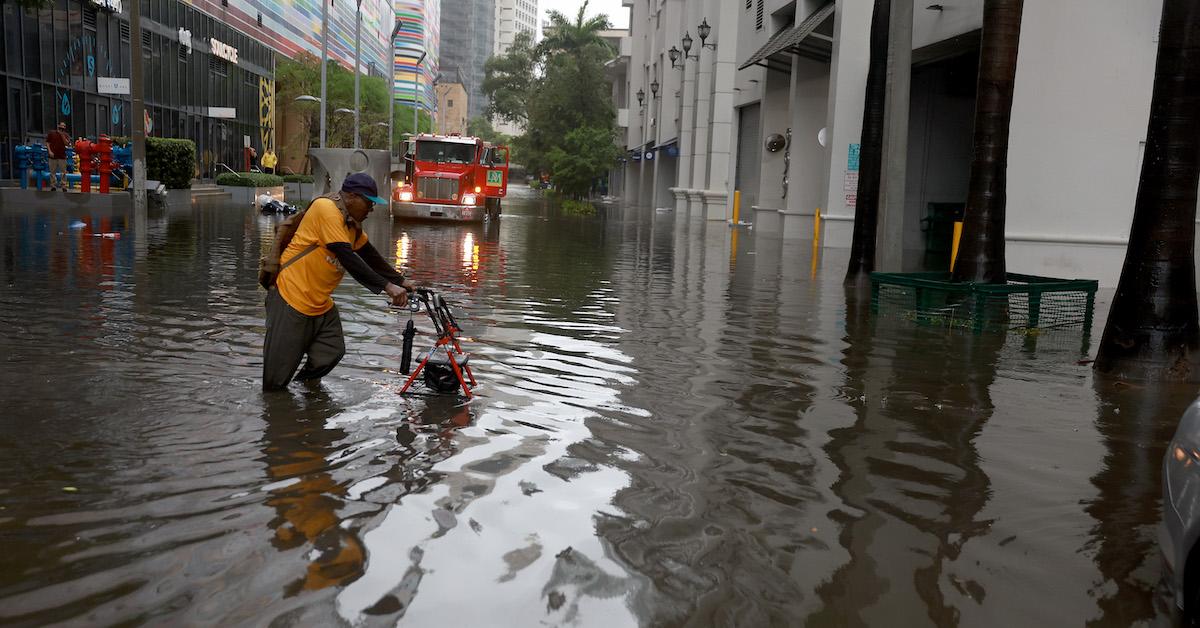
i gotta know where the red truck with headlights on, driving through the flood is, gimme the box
[391,133,509,222]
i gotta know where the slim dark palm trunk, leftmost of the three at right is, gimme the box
[846,0,892,286]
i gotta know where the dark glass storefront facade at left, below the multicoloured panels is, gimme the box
[0,0,275,179]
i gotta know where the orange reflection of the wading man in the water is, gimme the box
[263,395,366,594]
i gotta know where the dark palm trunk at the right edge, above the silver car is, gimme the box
[1096,0,1200,382]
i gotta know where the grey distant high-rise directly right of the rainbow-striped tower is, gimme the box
[440,0,497,118]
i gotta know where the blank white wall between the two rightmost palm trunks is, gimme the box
[1006,0,1162,285]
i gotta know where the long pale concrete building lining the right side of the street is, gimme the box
[613,0,1162,286]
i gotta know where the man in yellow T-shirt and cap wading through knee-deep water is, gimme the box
[263,173,413,390]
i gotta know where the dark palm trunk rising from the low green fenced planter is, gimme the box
[954,0,1024,283]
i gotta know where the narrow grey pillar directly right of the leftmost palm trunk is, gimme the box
[875,1,912,273]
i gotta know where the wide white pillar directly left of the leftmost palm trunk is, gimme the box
[821,0,873,247]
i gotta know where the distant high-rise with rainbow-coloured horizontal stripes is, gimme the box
[392,0,442,110]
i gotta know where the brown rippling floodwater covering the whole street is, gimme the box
[0,194,1193,627]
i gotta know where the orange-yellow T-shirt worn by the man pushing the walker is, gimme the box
[275,198,367,316]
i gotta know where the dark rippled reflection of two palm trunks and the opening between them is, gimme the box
[809,298,1006,626]
